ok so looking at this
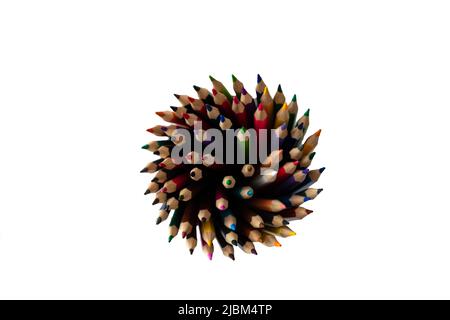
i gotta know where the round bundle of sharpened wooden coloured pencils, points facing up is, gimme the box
[141,75,325,260]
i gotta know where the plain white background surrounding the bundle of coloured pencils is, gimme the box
[0,0,450,299]
